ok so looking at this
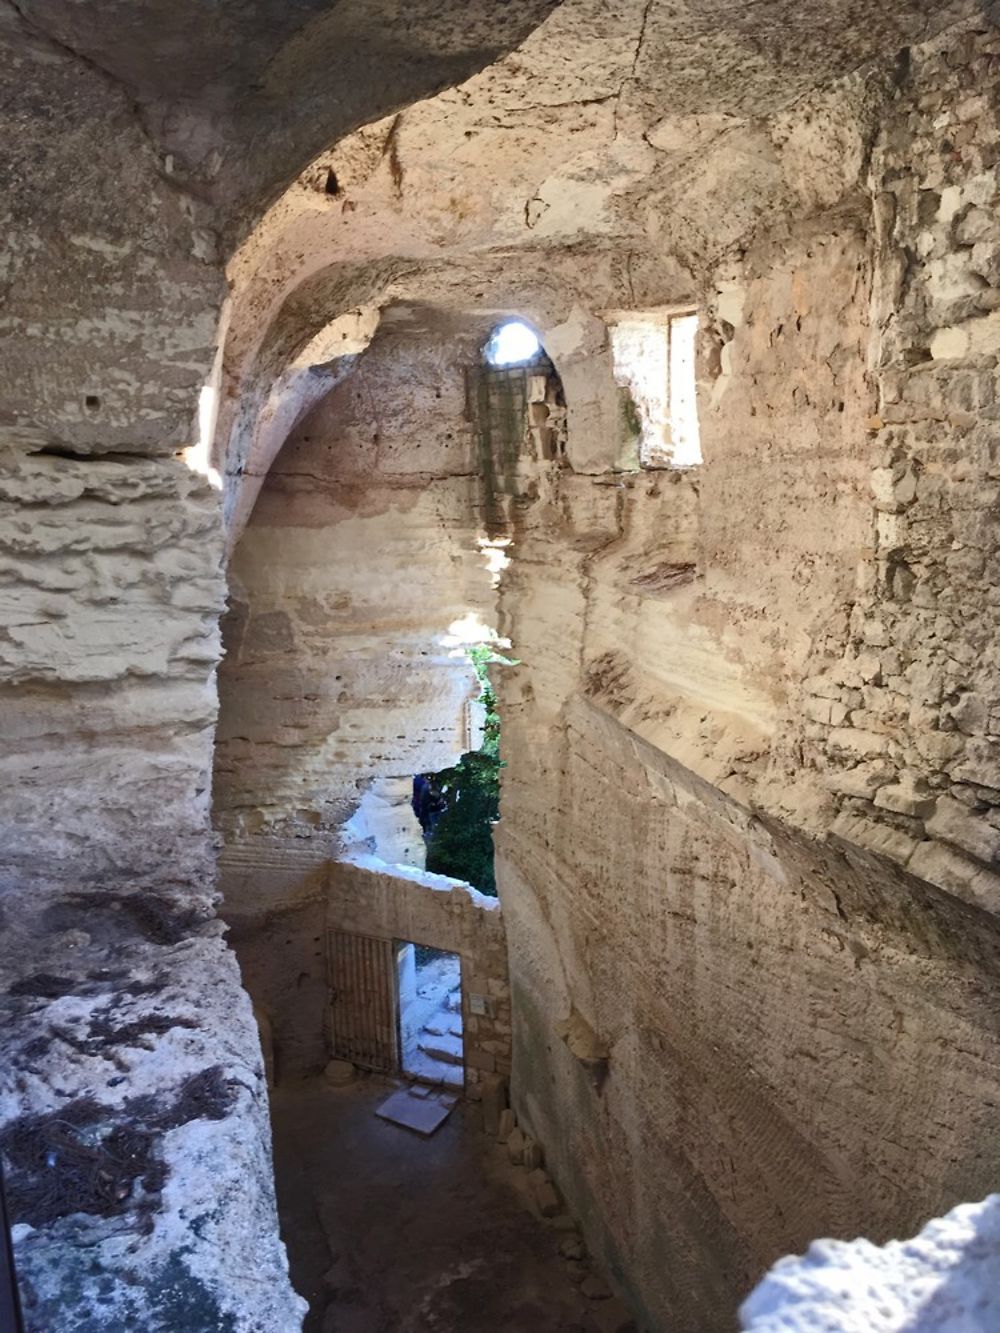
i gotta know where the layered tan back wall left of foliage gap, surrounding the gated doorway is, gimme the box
[215,313,511,1088]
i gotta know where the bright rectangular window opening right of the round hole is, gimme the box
[609,309,701,468]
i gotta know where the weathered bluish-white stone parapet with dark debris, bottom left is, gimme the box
[0,882,304,1333]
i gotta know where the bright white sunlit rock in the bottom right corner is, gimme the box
[740,1194,1000,1333]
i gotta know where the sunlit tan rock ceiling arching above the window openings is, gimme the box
[216,0,986,530]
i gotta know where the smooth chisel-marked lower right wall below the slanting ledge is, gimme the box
[499,702,1000,1329]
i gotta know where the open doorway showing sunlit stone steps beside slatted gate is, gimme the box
[396,940,465,1088]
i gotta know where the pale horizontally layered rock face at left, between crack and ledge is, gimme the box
[0,447,224,901]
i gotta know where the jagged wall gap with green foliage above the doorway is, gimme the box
[427,644,511,897]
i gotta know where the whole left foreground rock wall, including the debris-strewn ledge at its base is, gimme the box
[0,31,303,1333]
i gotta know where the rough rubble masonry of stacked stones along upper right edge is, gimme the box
[805,23,1000,910]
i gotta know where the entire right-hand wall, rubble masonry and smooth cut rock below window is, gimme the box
[499,20,999,1329]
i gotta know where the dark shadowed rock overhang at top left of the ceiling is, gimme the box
[5,0,565,221]
